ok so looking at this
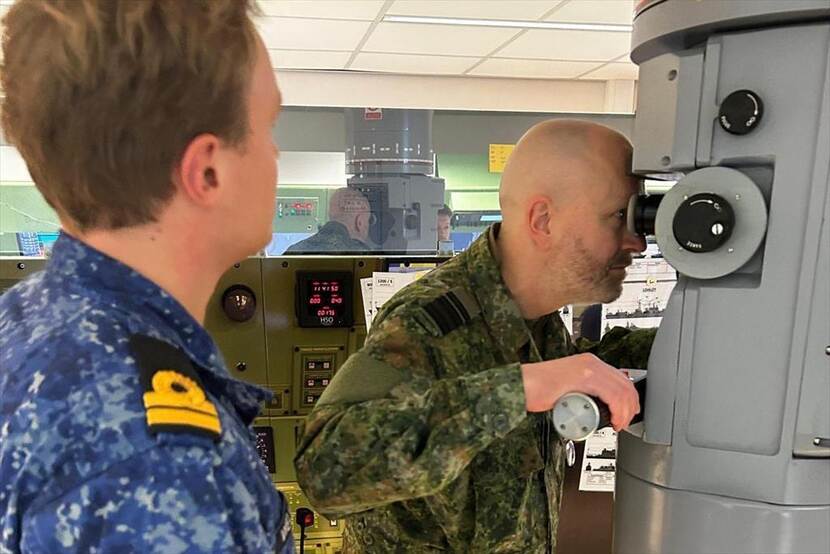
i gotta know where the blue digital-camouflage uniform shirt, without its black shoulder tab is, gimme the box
[0,235,294,554]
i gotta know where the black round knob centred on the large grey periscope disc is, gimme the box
[672,193,735,252]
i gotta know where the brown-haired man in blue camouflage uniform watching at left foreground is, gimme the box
[0,0,294,554]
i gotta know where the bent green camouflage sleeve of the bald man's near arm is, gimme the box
[295,308,527,518]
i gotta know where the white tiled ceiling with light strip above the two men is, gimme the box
[258,0,637,81]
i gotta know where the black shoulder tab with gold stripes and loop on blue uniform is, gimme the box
[130,335,222,440]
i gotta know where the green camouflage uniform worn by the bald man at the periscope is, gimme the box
[295,222,647,554]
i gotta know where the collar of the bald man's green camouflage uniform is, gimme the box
[466,223,530,358]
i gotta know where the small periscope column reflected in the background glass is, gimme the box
[345,108,444,254]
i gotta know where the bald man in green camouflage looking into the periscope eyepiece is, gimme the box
[295,120,653,554]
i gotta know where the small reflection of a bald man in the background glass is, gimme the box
[285,188,371,255]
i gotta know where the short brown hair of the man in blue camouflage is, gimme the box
[0,0,257,230]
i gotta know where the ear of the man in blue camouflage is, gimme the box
[173,134,221,206]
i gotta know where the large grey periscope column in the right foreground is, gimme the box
[614,0,830,554]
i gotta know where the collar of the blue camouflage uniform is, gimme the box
[48,232,271,417]
